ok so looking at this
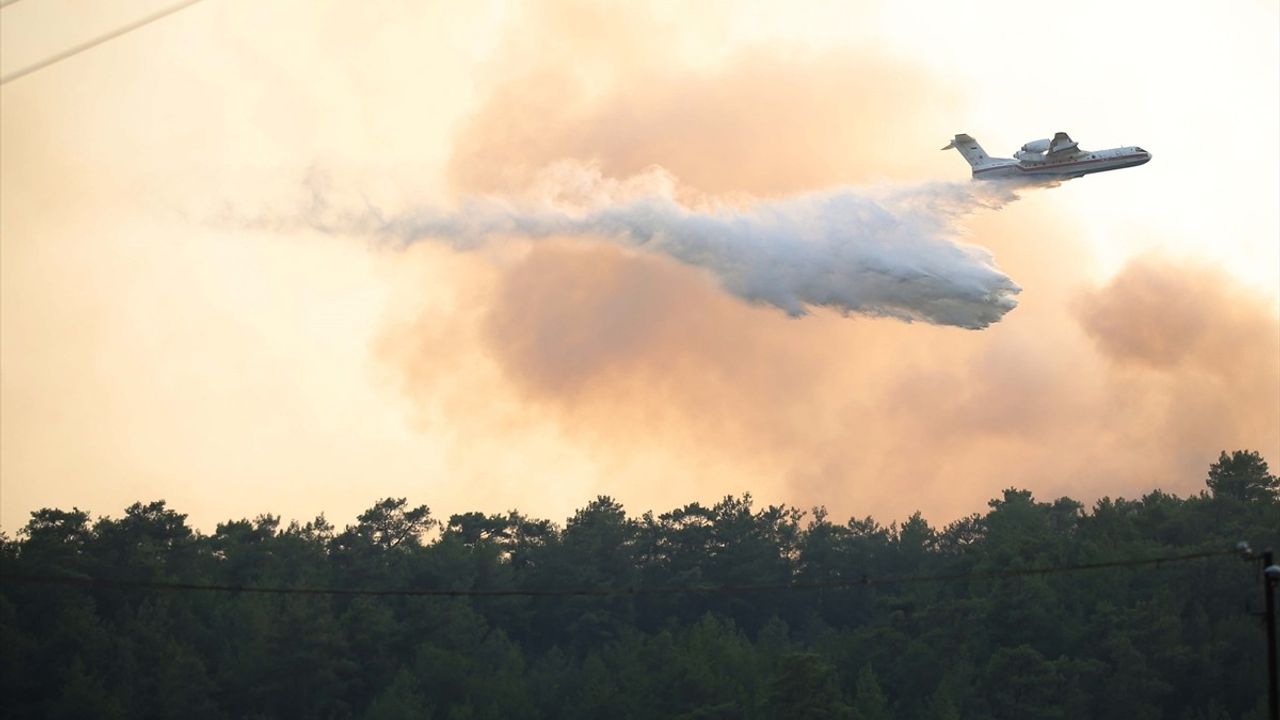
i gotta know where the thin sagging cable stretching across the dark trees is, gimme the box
[0,550,1235,597]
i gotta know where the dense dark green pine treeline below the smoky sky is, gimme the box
[0,451,1280,720]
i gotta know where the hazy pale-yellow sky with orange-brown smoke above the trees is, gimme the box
[0,0,1280,533]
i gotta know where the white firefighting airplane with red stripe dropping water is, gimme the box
[943,132,1151,181]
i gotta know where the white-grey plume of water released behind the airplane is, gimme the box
[299,164,1019,329]
